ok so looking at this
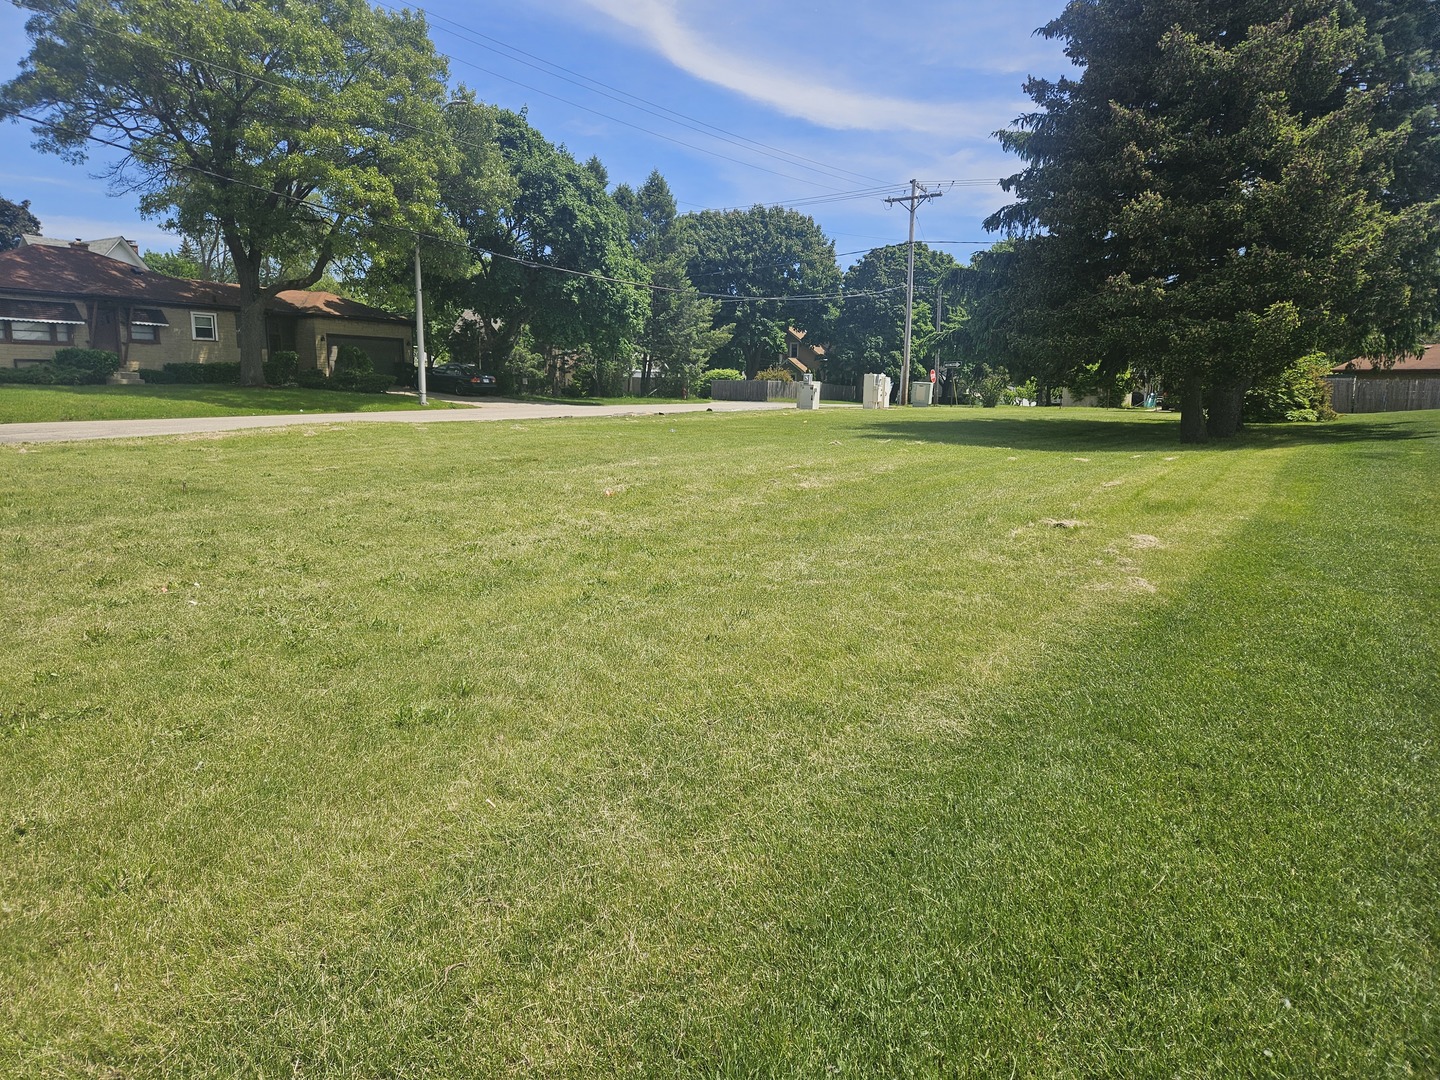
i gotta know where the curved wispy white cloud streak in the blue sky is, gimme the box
[586,0,1012,138]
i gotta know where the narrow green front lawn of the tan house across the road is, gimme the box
[0,384,465,423]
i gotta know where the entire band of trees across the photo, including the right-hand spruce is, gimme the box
[0,0,1440,439]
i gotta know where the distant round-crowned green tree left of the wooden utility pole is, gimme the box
[678,206,840,379]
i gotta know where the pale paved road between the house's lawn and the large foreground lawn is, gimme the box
[0,397,795,444]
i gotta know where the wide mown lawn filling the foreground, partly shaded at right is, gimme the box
[0,408,1440,1077]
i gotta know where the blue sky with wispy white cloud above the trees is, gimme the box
[0,0,1068,265]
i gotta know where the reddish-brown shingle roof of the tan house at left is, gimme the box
[0,245,408,323]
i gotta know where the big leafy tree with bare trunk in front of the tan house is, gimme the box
[0,0,451,384]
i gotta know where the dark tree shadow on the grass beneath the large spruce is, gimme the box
[864,409,1440,452]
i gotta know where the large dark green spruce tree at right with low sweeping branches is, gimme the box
[979,0,1440,441]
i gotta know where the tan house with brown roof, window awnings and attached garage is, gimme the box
[0,240,410,372]
